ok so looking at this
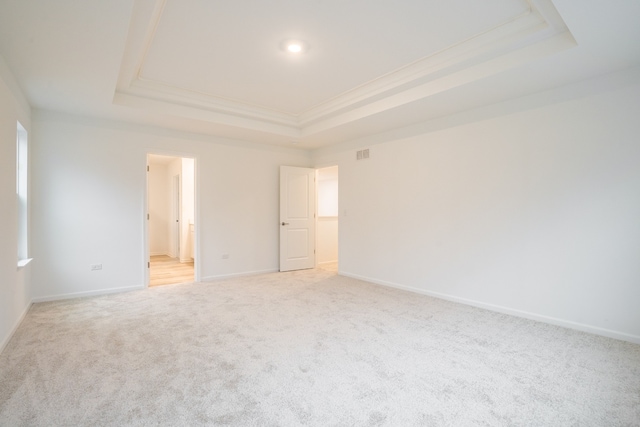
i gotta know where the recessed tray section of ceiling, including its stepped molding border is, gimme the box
[114,0,576,141]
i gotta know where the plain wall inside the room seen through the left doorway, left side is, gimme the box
[148,164,171,256]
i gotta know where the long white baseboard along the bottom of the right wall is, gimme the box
[339,271,640,344]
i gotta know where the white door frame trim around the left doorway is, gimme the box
[141,150,201,288]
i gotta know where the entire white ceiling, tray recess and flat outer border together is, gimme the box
[0,0,640,149]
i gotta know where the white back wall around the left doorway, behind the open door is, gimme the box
[33,111,310,300]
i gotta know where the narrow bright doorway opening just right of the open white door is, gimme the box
[316,166,339,271]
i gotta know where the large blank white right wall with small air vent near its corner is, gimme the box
[315,69,640,342]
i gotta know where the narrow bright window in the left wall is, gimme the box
[16,122,31,268]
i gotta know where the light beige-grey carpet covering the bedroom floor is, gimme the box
[0,269,640,426]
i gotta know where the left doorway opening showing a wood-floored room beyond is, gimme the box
[147,154,197,286]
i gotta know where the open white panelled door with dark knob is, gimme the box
[280,166,316,271]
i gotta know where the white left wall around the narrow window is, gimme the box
[0,57,33,351]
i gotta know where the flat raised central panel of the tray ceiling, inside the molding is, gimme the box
[139,0,530,116]
